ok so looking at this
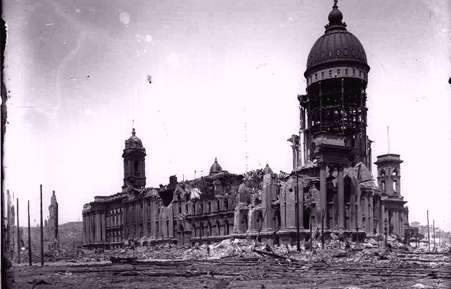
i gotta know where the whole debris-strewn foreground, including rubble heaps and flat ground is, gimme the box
[8,240,451,289]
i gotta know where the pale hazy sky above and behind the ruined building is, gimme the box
[3,0,451,230]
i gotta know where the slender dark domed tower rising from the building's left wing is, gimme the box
[122,128,146,189]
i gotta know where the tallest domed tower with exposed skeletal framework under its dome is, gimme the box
[298,1,371,168]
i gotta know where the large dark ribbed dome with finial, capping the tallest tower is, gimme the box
[305,1,369,77]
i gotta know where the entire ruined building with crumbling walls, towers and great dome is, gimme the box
[83,3,408,247]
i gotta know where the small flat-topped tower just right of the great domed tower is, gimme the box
[375,154,402,196]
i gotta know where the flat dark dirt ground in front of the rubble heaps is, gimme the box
[8,253,451,289]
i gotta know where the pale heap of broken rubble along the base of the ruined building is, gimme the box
[71,236,450,267]
